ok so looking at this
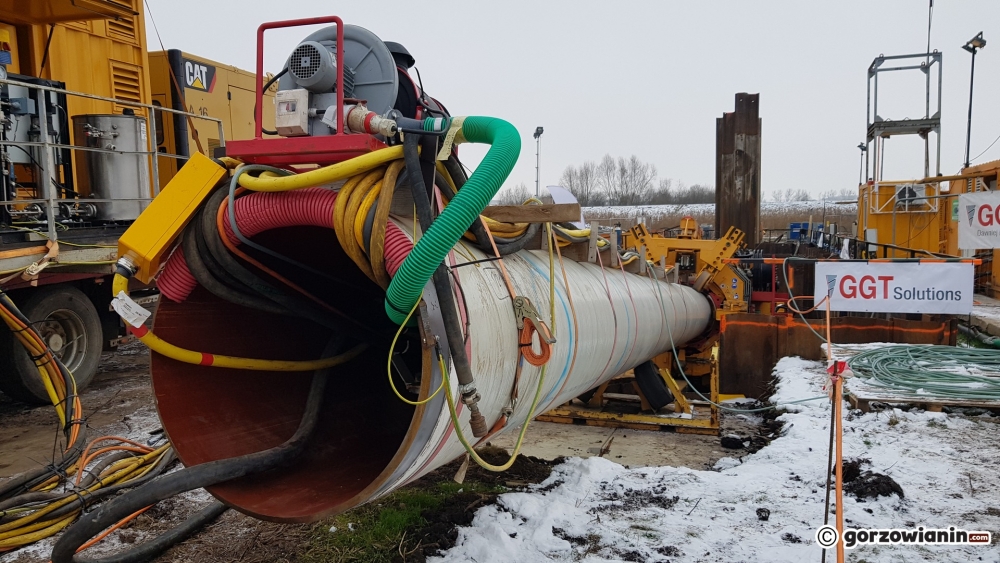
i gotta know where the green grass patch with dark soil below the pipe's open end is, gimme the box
[300,481,506,563]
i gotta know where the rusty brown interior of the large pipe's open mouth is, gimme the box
[152,227,421,522]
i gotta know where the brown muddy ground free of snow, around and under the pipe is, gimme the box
[0,343,764,563]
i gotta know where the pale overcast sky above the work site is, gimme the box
[147,0,1000,203]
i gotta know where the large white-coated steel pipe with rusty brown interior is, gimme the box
[152,219,712,522]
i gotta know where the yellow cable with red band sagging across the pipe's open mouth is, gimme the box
[112,274,368,371]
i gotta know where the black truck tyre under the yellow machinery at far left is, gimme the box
[0,285,104,404]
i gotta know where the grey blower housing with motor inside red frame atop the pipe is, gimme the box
[278,24,399,136]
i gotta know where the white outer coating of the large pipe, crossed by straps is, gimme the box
[368,219,712,498]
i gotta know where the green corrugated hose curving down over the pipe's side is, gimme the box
[385,117,521,324]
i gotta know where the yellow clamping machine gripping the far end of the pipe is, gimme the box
[538,226,750,434]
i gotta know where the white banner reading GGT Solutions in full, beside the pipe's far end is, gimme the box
[813,261,975,315]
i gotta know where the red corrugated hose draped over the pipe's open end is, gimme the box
[157,188,413,303]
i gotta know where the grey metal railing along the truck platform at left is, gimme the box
[0,79,226,241]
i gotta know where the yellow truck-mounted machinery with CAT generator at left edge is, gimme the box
[0,0,274,402]
